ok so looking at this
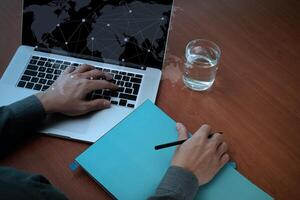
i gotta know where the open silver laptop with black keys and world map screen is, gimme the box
[0,0,173,142]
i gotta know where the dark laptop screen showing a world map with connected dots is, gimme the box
[22,0,173,69]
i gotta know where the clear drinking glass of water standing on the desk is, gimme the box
[183,39,221,91]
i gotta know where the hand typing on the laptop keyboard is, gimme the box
[36,65,118,116]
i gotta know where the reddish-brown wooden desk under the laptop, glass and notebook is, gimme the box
[0,0,300,200]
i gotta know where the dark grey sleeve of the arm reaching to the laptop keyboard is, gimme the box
[0,95,46,158]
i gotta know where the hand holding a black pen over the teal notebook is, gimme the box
[172,123,229,185]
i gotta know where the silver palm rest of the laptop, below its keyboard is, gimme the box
[0,83,137,142]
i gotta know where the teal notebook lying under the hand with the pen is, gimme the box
[75,100,272,200]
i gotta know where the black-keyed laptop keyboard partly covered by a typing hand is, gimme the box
[17,56,143,108]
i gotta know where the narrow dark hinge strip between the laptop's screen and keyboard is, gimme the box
[34,47,147,70]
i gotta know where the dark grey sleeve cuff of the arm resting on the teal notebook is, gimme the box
[148,166,198,200]
